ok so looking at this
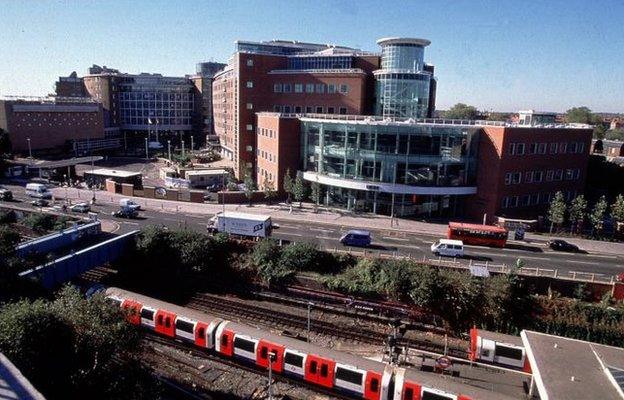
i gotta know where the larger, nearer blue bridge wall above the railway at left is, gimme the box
[20,231,139,289]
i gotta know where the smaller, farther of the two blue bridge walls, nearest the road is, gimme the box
[15,221,102,257]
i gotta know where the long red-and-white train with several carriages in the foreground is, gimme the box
[106,288,509,400]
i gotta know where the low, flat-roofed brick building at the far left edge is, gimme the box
[0,98,104,155]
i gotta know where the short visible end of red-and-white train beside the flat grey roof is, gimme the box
[468,328,531,374]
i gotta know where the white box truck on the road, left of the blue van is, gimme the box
[207,211,272,237]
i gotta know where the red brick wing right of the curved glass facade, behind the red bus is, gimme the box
[466,126,592,223]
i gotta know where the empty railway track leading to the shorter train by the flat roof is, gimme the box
[187,294,468,360]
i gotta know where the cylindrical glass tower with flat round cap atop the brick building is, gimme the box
[374,38,432,118]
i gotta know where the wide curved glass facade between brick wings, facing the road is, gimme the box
[301,119,478,215]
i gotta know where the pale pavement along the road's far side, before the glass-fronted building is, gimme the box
[52,188,624,255]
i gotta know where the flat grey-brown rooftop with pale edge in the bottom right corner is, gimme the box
[521,331,624,400]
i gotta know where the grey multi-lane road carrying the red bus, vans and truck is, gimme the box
[5,185,624,276]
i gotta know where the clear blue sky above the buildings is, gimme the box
[0,0,624,112]
